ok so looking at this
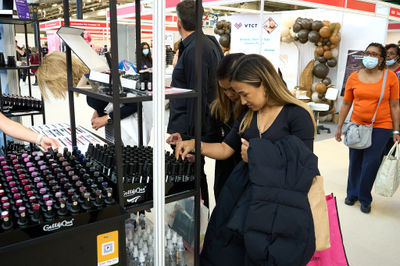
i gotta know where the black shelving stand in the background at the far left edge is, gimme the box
[0,17,46,150]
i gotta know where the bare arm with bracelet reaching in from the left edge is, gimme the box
[0,113,60,150]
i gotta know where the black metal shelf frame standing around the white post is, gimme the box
[63,0,202,265]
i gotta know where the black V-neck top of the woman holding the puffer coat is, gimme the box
[224,104,314,151]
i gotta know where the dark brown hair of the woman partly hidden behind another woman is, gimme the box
[211,53,244,123]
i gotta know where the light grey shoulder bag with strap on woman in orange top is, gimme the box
[343,70,388,150]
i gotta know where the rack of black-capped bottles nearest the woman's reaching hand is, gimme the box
[86,144,194,206]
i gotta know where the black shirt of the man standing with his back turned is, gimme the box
[168,33,223,141]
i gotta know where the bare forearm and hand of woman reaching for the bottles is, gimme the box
[175,139,235,160]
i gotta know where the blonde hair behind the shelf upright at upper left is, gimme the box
[36,52,89,99]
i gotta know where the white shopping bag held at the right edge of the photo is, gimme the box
[375,142,400,197]
